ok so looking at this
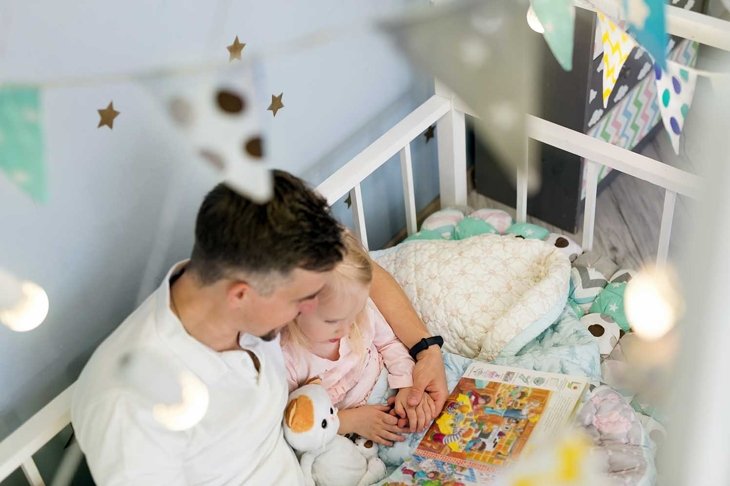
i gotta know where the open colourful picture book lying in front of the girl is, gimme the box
[386,361,588,484]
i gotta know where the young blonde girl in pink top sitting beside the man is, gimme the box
[281,231,435,446]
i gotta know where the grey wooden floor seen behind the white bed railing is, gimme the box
[469,132,694,269]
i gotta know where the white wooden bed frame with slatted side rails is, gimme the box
[0,0,730,486]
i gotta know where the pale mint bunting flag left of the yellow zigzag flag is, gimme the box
[532,0,575,71]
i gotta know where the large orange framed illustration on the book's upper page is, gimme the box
[416,374,551,467]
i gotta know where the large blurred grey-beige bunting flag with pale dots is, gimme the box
[381,0,540,184]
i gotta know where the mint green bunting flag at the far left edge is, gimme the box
[0,87,47,202]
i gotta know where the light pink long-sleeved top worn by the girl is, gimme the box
[281,299,415,409]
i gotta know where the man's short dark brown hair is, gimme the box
[188,170,344,284]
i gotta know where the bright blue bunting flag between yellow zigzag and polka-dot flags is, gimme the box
[624,0,668,69]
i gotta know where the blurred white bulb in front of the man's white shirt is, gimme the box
[118,349,210,431]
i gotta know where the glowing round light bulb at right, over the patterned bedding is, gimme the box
[624,266,684,341]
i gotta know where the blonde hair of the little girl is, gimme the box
[286,229,373,358]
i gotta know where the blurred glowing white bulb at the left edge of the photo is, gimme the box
[0,270,49,332]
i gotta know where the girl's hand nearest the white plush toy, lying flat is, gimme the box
[338,405,408,446]
